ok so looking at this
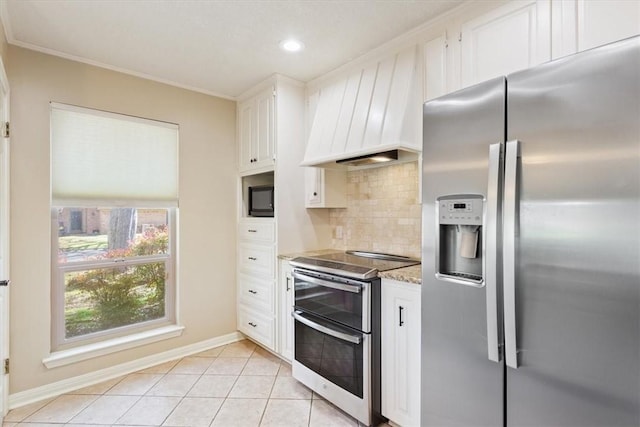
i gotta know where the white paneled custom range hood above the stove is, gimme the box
[302,47,422,167]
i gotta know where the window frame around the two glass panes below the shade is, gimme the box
[51,206,177,351]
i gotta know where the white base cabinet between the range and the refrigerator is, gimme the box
[381,279,421,427]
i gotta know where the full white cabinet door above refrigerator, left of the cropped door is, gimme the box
[460,0,551,87]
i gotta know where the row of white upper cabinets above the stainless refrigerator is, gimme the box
[422,0,640,101]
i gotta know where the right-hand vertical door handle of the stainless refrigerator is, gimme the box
[502,140,520,369]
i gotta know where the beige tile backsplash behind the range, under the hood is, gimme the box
[329,161,422,258]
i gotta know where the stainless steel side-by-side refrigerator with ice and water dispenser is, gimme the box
[421,37,640,427]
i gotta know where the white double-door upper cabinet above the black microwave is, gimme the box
[238,86,275,173]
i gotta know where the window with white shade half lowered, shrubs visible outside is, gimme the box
[51,103,178,350]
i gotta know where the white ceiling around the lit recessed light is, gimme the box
[0,0,462,99]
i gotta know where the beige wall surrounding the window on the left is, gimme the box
[6,46,237,393]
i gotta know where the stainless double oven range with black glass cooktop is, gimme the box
[290,251,419,426]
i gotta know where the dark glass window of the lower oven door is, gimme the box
[294,319,366,398]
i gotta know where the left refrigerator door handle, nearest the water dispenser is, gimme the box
[483,143,502,362]
